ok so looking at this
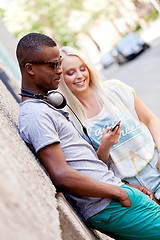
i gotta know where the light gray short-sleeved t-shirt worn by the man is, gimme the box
[19,99,122,219]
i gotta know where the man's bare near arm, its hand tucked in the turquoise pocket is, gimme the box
[38,143,131,207]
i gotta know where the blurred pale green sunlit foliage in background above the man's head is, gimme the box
[0,0,156,48]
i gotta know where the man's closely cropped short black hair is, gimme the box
[16,33,57,67]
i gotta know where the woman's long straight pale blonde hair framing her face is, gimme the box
[59,46,131,130]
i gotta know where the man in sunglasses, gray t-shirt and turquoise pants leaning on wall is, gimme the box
[17,33,160,240]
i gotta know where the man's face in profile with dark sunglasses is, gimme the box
[33,46,62,92]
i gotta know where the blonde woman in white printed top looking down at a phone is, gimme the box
[60,47,160,200]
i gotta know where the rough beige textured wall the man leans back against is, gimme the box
[0,82,62,240]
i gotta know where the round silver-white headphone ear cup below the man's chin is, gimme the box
[47,91,67,109]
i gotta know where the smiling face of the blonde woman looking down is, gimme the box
[62,56,90,95]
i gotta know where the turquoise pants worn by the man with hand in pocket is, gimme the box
[87,185,160,240]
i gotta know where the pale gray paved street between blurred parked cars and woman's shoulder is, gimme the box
[100,23,160,119]
